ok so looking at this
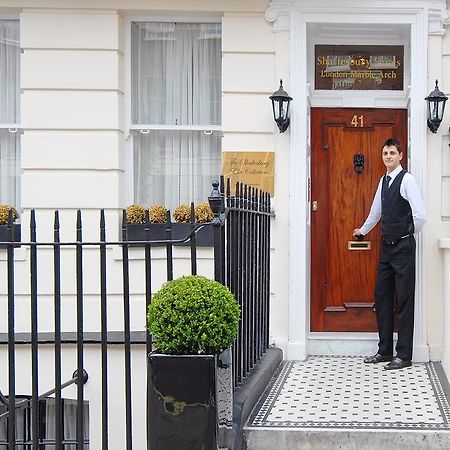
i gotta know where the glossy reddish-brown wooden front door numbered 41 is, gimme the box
[311,108,407,331]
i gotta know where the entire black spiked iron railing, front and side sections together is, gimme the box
[0,179,270,450]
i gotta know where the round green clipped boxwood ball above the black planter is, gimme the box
[147,275,240,355]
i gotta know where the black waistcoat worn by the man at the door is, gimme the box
[381,170,414,240]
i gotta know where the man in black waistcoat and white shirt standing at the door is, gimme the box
[353,139,425,370]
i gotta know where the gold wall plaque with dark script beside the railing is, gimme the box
[222,152,275,196]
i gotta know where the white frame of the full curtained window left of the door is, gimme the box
[124,15,222,205]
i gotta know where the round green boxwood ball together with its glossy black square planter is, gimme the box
[147,275,240,450]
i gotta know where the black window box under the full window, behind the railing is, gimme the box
[127,223,214,247]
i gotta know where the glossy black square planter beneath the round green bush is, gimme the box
[148,353,217,450]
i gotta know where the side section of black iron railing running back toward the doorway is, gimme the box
[223,180,271,386]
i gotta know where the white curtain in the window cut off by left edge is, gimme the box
[0,20,20,207]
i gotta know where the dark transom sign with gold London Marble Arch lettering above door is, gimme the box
[314,45,404,91]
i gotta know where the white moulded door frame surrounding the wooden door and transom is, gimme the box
[266,0,446,361]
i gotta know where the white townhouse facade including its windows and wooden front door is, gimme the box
[0,0,450,448]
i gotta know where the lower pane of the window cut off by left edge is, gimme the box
[0,129,20,208]
